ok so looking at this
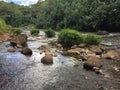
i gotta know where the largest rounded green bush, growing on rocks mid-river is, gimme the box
[58,29,83,47]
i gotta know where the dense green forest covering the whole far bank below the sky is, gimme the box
[0,0,120,31]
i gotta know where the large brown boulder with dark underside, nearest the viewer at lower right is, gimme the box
[83,56,102,69]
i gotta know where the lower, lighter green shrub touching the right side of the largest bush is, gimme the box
[83,33,102,45]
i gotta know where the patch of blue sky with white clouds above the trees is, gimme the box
[3,0,38,6]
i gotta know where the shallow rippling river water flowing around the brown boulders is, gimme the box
[0,31,120,90]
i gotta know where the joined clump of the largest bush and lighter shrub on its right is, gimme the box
[58,29,102,47]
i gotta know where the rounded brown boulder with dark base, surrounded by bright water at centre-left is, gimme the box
[41,53,53,64]
